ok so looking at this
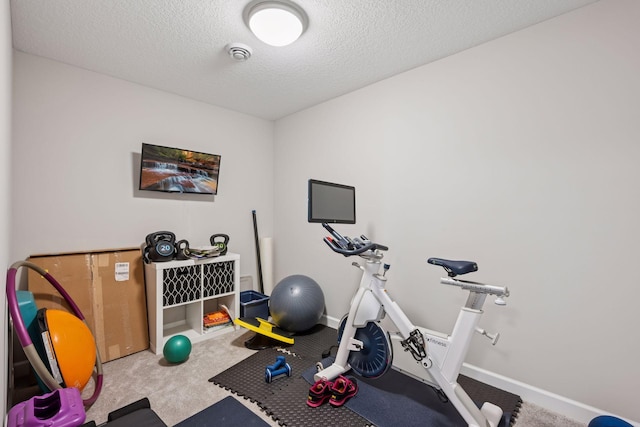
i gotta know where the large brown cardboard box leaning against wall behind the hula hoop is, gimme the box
[28,248,149,362]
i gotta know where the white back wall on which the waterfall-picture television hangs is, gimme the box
[11,52,273,275]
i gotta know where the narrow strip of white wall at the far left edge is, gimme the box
[0,2,12,424]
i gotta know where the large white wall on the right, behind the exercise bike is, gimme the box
[275,0,640,420]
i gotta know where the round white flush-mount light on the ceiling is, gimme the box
[243,0,309,46]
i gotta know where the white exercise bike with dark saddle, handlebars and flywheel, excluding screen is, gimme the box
[314,223,509,427]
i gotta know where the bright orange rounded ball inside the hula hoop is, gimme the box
[43,309,96,391]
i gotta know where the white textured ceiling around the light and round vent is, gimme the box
[11,0,596,120]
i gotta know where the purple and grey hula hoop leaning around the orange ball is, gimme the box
[7,261,103,406]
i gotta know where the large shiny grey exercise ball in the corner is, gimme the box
[269,274,324,332]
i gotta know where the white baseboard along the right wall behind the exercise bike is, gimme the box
[322,316,640,427]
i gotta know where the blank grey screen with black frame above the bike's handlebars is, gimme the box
[308,179,356,224]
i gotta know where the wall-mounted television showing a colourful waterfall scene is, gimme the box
[140,143,220,194]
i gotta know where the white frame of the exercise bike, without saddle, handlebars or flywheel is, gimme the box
[314,251,509,427]
